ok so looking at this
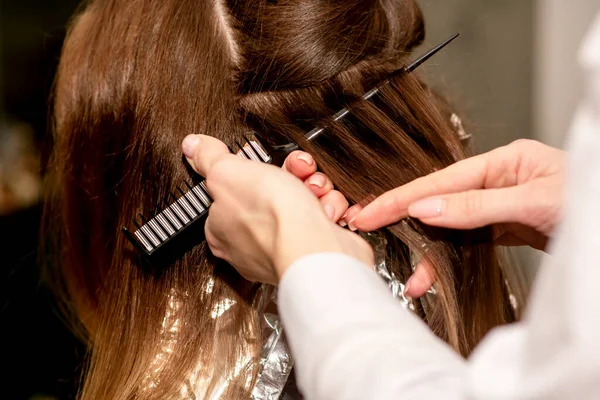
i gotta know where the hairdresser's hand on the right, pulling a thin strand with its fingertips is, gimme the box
[348,140,565,297]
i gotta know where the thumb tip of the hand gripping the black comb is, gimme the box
[181,135,233,177]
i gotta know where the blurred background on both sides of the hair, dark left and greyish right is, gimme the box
[0,0,600,399]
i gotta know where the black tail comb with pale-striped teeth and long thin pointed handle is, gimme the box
[122,34,458,264]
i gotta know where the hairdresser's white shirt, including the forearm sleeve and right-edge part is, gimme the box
[279,13,600,400]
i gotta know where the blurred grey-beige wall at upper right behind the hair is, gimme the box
[417,0,600,281]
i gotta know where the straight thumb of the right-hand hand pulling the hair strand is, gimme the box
[408,184,547,229]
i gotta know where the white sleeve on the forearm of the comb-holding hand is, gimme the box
[278,254,466,400]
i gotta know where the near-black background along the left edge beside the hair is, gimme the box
[0,0,84,399]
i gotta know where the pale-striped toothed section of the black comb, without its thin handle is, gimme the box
[123,139,271,256]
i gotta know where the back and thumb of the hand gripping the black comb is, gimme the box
[183,135,373,283]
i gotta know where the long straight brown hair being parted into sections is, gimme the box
[44,0,516,399]
